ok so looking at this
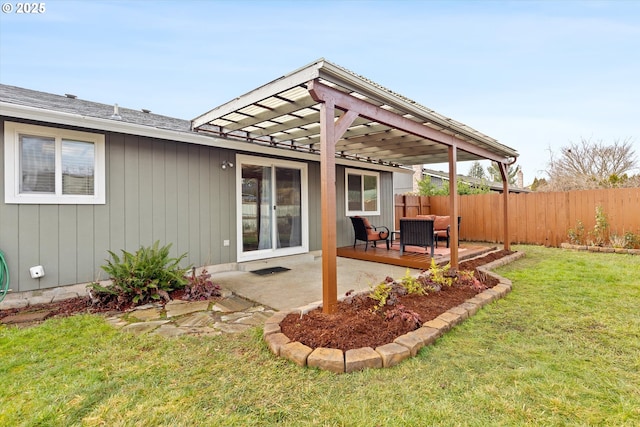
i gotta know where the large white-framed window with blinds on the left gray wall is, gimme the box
[4,122,105,204]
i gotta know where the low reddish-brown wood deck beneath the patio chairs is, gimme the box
[337,244,496,269]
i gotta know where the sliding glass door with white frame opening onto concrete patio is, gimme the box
[237,156,309,261]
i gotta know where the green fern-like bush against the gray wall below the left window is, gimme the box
[89,241,189,306]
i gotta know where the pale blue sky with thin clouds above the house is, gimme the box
[0,0,640,184]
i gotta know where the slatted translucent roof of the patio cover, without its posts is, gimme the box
[192,59,518,165]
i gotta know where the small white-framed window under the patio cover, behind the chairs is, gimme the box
[345,169,380,216]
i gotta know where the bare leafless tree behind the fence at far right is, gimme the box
[544,138,637,191]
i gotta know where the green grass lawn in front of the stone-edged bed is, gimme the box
[0,246,640,426]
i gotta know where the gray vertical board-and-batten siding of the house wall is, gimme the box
[0,117,393,292]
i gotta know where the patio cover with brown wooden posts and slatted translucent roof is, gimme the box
[192,59,518,313]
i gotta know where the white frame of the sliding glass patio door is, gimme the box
[235,154,309,262]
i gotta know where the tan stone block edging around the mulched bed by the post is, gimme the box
[263,252,525,374]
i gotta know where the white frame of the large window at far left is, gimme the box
[4,122,106,205]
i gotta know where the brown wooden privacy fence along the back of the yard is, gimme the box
[396,188,640,247]
